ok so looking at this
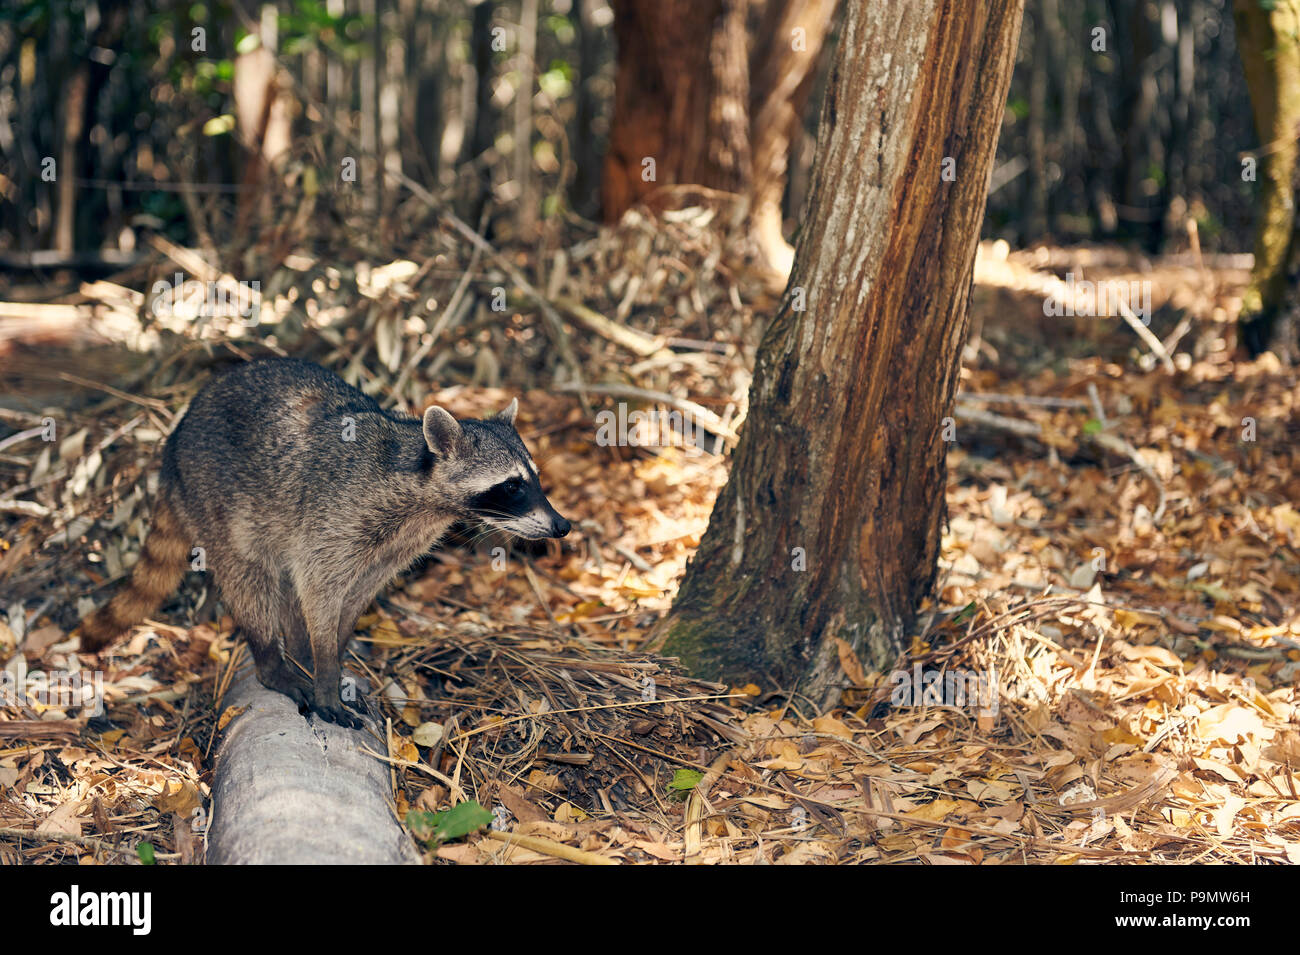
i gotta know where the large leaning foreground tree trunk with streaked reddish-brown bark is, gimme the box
[655,0,1023,702]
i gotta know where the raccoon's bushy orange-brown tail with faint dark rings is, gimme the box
[81,492,190,654]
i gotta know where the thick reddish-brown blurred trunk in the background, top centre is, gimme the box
[602,0,751,222]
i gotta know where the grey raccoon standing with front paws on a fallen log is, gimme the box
[81,359,571,728]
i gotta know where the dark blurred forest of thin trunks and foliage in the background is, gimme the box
[0,0,1257,252]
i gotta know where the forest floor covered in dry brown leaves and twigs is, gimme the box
[0,210,1300,864]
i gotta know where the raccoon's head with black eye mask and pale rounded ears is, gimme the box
[424,398,571,541]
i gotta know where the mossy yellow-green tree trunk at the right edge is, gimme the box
[1234,0,1300,359]
